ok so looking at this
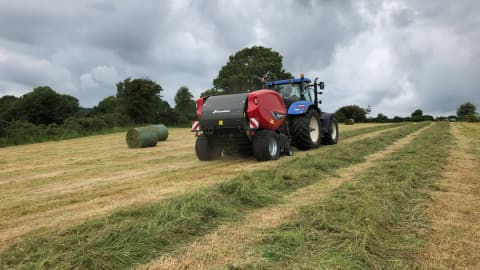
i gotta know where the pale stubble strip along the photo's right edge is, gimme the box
[417,122,480,270]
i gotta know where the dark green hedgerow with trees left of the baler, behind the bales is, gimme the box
[0,78,195,146]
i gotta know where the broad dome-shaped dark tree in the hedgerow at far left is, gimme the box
[13,86,80,125]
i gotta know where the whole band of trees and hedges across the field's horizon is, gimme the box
[0,46,478,146]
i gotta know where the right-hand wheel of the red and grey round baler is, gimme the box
[252,130,280,161]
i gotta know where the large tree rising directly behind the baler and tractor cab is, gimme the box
[213,46,292,94]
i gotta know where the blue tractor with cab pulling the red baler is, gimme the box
[265,74,339,150]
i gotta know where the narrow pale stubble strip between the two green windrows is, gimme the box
[139,123,426,269]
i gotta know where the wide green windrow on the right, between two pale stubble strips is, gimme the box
[246,123,452,269]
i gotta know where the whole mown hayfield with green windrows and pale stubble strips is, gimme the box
[0,123,480,269]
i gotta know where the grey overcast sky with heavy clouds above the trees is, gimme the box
[0,0,480,117]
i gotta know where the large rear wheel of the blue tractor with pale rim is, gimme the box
[290,109,322,150]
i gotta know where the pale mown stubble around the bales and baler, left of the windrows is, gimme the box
[0,124,398,250]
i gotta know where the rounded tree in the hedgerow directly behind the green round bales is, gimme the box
[117,78,163,124]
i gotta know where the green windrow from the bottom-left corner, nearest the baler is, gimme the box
[0,124,425,269]
